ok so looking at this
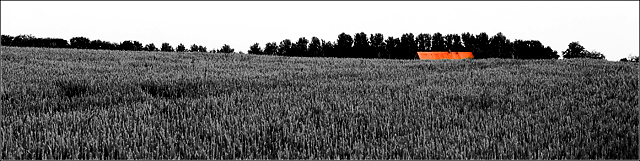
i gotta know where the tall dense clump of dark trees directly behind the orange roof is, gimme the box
[248,32,560,59]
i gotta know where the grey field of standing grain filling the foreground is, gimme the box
[0,47,640,159]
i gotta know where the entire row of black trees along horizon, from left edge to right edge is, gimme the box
[2,32,624,62]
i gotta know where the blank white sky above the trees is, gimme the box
[0,1,640,61]
